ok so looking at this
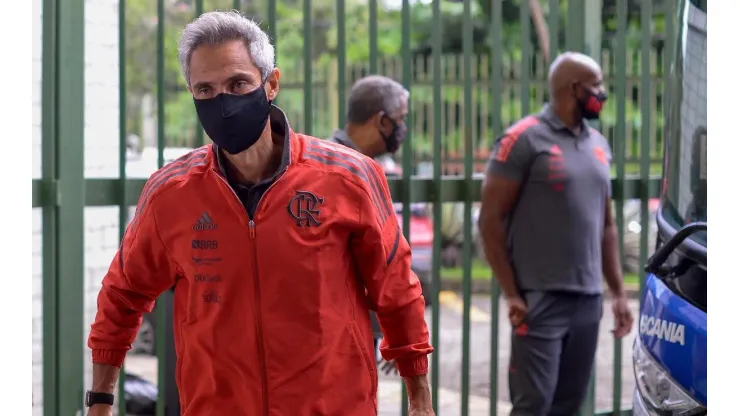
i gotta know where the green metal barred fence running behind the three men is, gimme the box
[32,0,664,416]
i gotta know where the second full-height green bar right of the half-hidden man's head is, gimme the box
[460,1,474,416]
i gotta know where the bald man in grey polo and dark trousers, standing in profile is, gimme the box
[479,52,632,416]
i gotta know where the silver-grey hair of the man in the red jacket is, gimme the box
[178,10,275,86]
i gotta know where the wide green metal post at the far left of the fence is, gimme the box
[42,0,85,415]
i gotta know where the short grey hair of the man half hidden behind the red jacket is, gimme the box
[347,75,409,124]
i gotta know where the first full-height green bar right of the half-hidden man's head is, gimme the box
[431,0,442,414]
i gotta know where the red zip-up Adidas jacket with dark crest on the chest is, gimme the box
[88,116,433,416]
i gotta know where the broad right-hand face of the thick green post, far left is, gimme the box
[54,0,85,415]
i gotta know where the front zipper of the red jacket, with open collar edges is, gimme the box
[217,167,288,416]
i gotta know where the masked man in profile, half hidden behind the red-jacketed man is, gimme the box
[327,75,409,374]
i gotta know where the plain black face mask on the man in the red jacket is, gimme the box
[193,84,270,155]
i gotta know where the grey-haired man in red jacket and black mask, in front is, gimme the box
[86,12,433,416]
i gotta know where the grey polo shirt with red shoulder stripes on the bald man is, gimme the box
[488,105,611,294]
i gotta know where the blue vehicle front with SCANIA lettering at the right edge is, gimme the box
[632,0,707,416]
